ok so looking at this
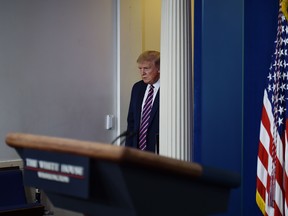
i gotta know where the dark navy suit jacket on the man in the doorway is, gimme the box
[125,80,160,152]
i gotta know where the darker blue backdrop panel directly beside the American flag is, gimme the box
[243,0,279,215]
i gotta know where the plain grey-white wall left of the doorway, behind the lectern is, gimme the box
[0,0,117,161]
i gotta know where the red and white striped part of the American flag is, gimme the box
[256,90,288,215]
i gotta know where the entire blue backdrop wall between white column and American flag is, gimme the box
[193,0,278,216]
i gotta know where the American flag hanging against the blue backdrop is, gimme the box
[256,2,288,216]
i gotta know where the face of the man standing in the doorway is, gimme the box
[138,61,160,85]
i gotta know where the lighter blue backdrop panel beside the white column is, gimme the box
[194,0,243,215]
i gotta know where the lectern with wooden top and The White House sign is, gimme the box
[6,133,240,216]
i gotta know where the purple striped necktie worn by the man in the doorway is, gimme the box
[138,85,154,150]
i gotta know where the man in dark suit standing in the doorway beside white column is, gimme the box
[126,51,160,152]
